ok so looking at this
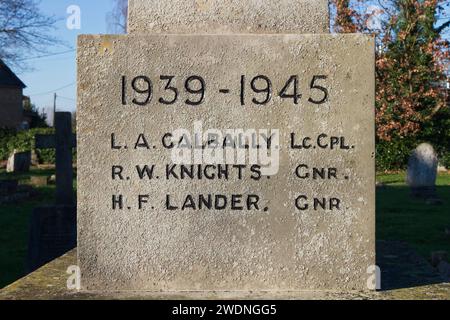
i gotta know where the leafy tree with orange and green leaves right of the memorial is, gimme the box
[332,0,450,170]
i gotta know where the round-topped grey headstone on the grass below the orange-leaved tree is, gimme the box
[406,143,438,199]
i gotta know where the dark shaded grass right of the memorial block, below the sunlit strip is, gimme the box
[377,186,450,290]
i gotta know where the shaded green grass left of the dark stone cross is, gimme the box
[0,169,76,288]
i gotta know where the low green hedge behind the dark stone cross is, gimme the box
[0,128,76,164]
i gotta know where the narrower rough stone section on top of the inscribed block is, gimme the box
[128,0,329,34]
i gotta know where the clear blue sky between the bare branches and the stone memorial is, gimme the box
[17,0,113,116]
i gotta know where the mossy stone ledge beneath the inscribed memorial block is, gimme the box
[0,248,450,300]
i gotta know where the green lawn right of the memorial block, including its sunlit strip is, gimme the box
[377,173,450,259]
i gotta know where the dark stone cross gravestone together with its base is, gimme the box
[27,112,77,272]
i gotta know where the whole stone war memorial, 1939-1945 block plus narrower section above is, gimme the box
[77,0,375,291]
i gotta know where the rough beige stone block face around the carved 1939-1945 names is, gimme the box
[77,33,375,291]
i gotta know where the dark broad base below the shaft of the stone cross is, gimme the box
[27,205,77,272]
